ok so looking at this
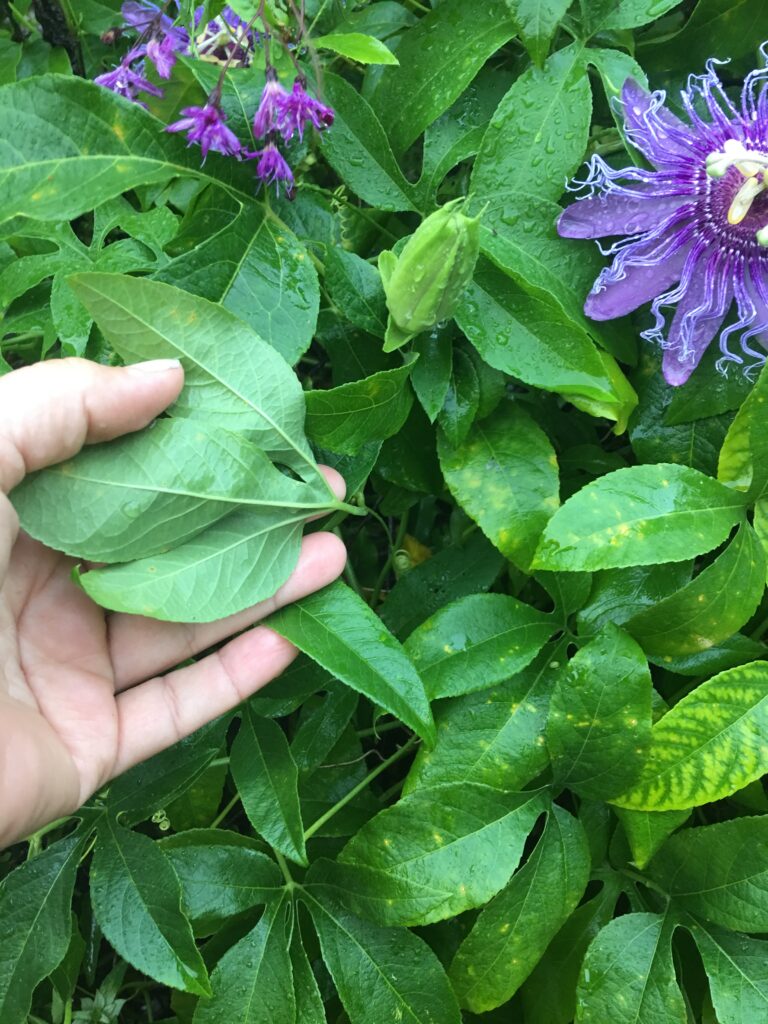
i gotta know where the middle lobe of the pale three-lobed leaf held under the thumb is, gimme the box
[12,419,328,562]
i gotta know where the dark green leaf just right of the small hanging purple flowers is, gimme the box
[319,73,416,210]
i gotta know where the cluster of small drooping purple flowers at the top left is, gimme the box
[95,0,334,198]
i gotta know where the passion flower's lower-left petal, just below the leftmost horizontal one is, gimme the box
[584,242,687,321]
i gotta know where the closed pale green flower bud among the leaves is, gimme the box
[379,199,481,352]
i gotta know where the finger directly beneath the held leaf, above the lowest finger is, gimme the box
[109,532,346,692]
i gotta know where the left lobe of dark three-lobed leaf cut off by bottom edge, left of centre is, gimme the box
[194,899,296,1024]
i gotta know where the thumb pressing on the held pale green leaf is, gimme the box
[0,359,184,494]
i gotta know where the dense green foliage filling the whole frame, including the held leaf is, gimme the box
[0,0,768,1024]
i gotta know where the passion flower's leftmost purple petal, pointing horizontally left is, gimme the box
[557,193,687,239]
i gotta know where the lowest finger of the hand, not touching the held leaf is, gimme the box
[113,626,297,776]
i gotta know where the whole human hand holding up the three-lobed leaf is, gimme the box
[0,359,345,848]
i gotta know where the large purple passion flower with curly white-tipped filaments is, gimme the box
[558,60,768,385]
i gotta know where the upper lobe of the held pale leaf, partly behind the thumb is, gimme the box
[70,273,313,470]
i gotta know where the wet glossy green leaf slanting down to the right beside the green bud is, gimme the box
[456,259,616,403]
